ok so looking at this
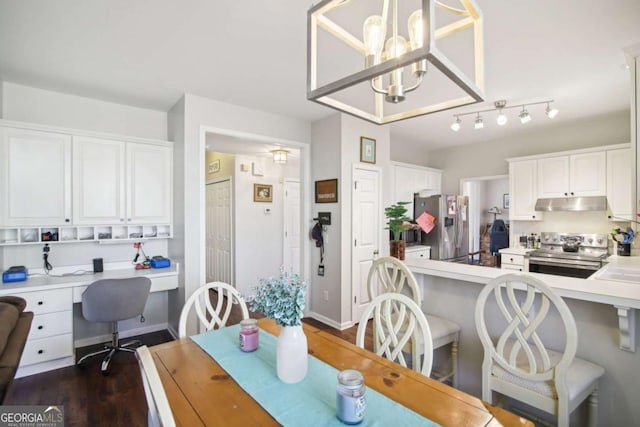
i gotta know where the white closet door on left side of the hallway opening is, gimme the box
[206,178,234,285]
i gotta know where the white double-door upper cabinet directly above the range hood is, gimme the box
[538,151,607,198]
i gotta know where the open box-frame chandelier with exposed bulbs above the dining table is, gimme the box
[307,0,484,124]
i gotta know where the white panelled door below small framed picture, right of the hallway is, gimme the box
[351,166,383,323]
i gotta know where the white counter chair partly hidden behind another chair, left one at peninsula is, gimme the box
[367,257,460,388]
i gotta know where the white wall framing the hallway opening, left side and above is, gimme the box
[168,94,310,331]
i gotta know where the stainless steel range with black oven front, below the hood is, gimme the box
[528,232,609,278]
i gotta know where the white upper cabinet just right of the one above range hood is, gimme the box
[607,148,633,221]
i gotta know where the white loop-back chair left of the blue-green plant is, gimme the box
[178,282,249,338]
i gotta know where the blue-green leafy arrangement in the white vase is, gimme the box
[247,268,307,326]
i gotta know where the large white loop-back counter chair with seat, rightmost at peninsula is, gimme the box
[475,274,604,427]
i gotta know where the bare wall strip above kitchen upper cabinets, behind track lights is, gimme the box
[429,111,630,194]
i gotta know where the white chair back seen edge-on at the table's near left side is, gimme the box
[136,345,176,427]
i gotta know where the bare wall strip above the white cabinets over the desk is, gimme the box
[3,82,167,140]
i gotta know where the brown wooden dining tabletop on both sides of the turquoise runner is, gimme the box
[150,319,533,427]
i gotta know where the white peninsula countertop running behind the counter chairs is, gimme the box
[405,255,640,308]
